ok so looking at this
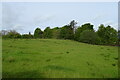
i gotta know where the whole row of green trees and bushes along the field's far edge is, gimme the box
[1,20,120,45]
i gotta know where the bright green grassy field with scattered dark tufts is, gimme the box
[2,39,118,78]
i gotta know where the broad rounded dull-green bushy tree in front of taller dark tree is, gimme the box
[78,30,99,44]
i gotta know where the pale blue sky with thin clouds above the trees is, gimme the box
[0,2,118,34]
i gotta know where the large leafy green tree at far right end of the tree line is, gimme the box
[97,24,118,45]
